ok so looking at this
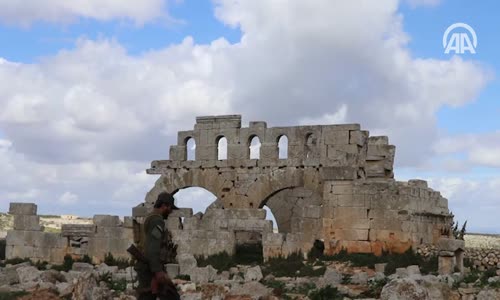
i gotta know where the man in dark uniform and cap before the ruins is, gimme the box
[135,192,180,300]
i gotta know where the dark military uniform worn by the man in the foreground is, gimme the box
[135,214,171,300]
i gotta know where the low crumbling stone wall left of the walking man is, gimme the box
[6,203,133,263]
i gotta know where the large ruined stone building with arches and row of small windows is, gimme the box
[137,115,452,257]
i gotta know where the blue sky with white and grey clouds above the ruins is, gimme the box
[0,0,500,233]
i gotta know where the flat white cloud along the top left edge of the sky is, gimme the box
[0,0,166,26]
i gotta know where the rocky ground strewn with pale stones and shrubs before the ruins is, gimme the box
[0,255,500,300]
